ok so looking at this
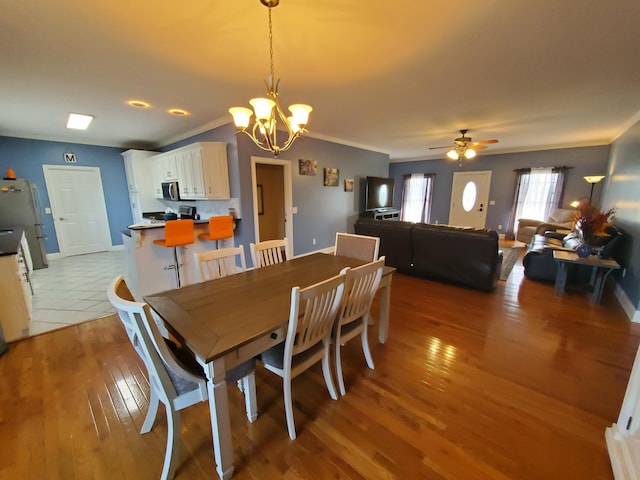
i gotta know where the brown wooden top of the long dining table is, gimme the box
[144,253,395,362]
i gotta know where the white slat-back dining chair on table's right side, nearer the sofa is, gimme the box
[332,257,385,395]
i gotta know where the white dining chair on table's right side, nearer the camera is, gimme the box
[260,275,345,440]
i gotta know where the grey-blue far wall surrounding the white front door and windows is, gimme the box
[389,146,609,233]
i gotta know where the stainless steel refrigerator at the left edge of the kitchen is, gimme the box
[0,178,49,269]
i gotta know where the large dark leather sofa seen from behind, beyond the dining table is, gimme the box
[354,218,502,291]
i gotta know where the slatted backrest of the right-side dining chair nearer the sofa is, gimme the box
[337,257,385,325]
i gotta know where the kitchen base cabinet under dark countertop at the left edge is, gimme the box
[0,237,32,342]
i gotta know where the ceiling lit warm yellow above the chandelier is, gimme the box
[0,0,640,160]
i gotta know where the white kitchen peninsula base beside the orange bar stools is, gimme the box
[122,220,238,299]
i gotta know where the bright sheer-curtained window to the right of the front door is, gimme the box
[507,167,569,238]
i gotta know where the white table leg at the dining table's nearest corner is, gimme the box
[205,358,234,480]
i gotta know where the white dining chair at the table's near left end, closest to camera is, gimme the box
[107,276,257,480]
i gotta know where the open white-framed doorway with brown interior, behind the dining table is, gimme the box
[251,157,293,252]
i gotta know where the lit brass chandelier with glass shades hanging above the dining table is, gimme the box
[229,0,313,157]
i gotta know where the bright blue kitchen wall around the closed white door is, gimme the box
[0,136,132,253]
